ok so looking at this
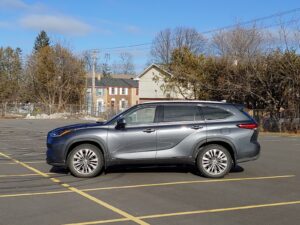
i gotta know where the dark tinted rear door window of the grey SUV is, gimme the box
[163,105,200,122]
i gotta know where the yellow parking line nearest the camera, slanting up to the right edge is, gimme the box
[65,201,300,225]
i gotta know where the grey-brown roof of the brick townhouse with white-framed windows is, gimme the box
[88,78,138,88]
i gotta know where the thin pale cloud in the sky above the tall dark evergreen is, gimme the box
[20,15,93,36]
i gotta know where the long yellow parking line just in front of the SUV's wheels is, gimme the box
[0,173,295,198]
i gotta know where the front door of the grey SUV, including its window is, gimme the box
[108,106,157,162]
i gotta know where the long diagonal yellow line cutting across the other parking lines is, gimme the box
[0,152,149,225]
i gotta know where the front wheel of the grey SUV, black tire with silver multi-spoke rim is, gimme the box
[67,144,104,178]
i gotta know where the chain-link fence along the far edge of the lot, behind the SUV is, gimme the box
[0,103,300,133]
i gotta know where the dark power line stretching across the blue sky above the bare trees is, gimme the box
[101,8,300,50]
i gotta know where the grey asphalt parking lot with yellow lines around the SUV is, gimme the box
[0,120,300,225]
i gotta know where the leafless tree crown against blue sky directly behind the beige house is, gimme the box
[151,27,206,65]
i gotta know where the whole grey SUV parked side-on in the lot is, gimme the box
[47,101,260,178]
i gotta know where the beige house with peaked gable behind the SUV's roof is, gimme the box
[136,64,184,103]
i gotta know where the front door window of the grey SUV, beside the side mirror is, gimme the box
[124,107,156,125]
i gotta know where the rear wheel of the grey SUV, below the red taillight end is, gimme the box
[197,144,233,178]
